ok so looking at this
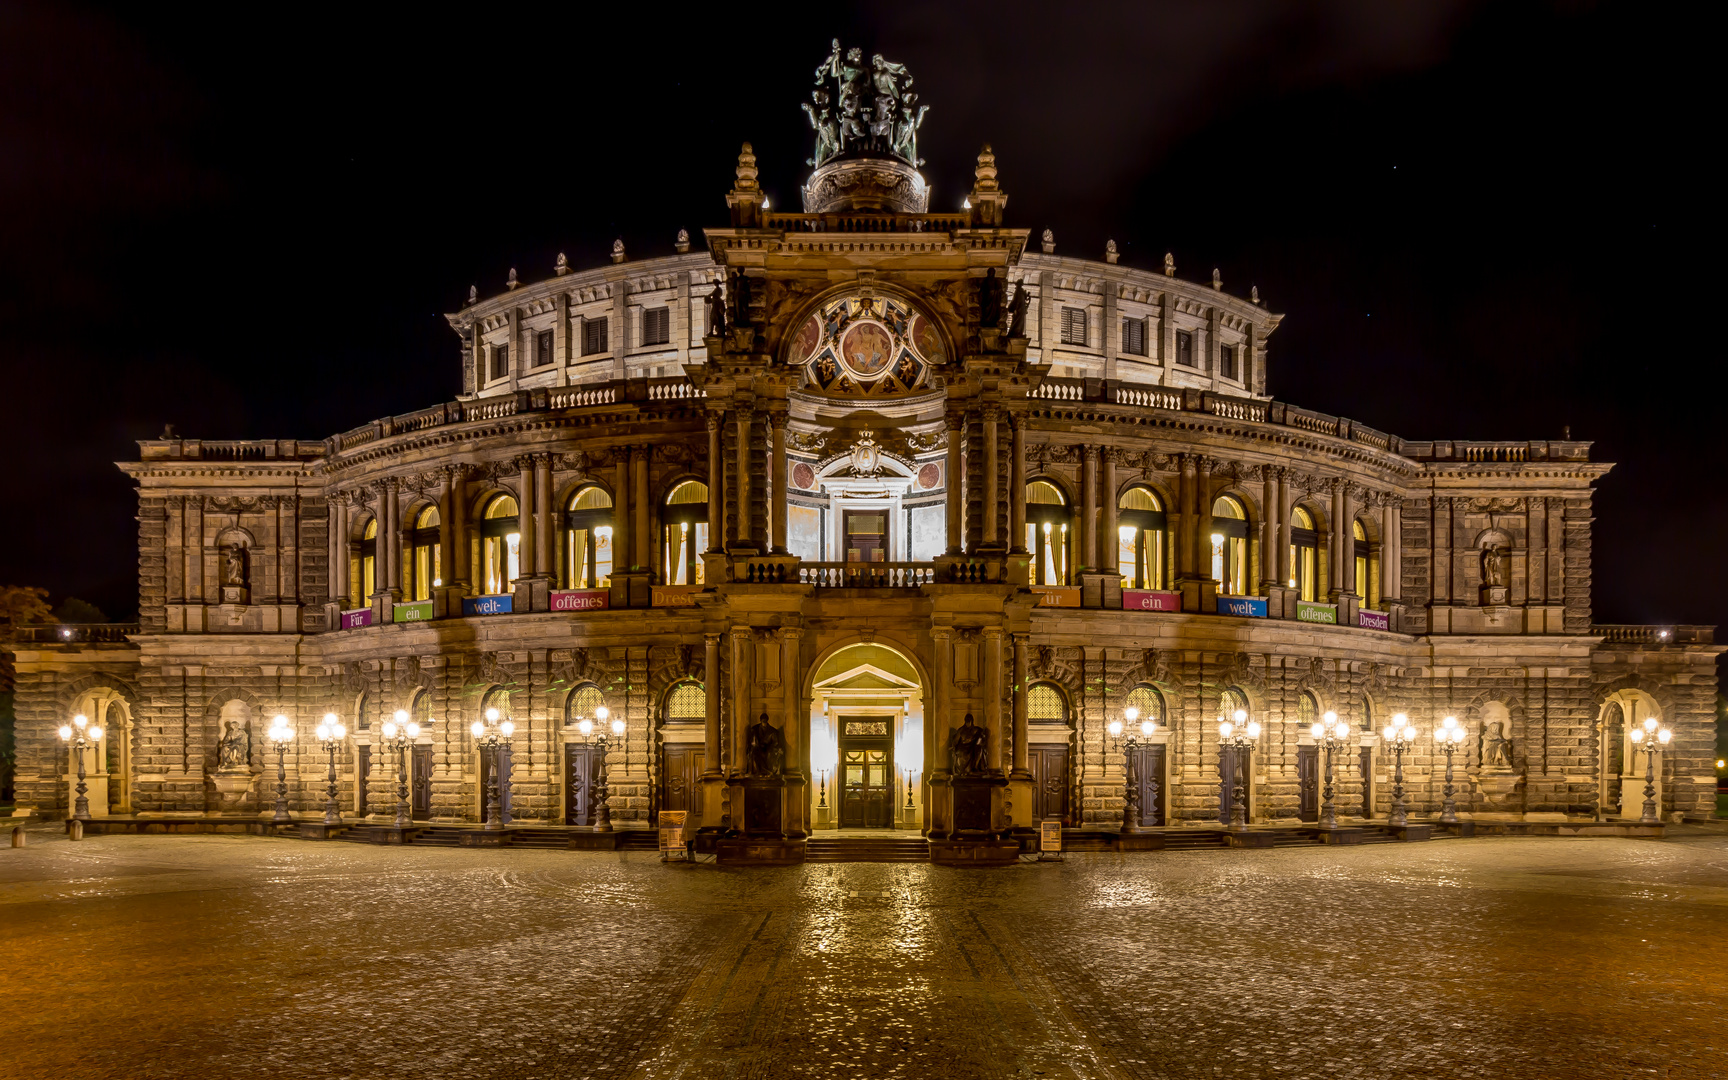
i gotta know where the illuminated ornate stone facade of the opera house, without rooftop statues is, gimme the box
[17,128,1719,838]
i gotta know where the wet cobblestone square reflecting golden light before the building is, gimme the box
[0,828,1728,1080]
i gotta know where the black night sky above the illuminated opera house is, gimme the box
[0,0,1728,622]
